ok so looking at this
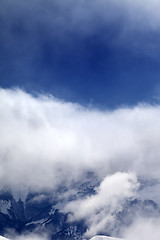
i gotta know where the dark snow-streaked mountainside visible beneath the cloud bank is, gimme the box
[0,176,160,240]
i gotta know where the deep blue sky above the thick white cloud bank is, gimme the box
[0,0,160,108]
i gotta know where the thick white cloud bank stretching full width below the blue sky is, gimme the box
[0,89,160,191]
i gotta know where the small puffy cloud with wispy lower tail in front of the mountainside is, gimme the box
[64,172,138,236]
